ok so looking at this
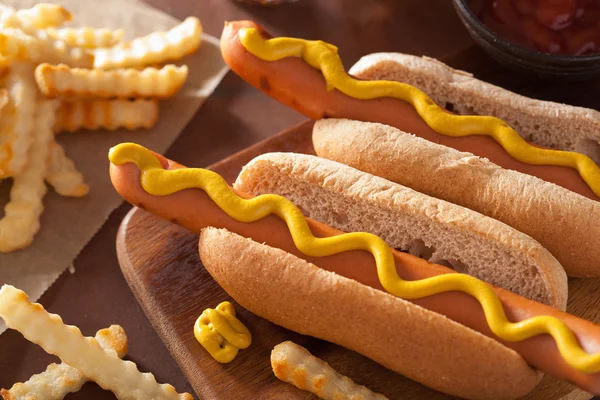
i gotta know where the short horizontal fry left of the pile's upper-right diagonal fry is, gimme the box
[46,26,125,49]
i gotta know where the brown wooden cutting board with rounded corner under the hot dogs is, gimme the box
[117,121,600,400]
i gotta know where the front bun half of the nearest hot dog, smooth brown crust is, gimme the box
[199,228,540,399]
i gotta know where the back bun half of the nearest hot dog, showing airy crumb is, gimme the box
[234,153,568,310]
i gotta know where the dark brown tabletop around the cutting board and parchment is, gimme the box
[0,0,600,400]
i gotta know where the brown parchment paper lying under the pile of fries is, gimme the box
[0,0,228,333]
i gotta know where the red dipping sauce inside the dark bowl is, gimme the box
[468,0,600,56]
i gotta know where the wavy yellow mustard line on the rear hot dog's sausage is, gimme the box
[238,28,600,196]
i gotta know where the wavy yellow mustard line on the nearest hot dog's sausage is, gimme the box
[108,143,600,373]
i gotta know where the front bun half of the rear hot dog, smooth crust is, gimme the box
[313,119,600,277]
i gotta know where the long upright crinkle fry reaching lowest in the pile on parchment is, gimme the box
[0,99,56,253]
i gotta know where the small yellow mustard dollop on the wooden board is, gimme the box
[194,301,252,363]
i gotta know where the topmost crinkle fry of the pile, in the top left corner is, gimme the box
[0,3,73,29]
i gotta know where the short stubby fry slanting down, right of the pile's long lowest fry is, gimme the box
[46,140,90,197]
